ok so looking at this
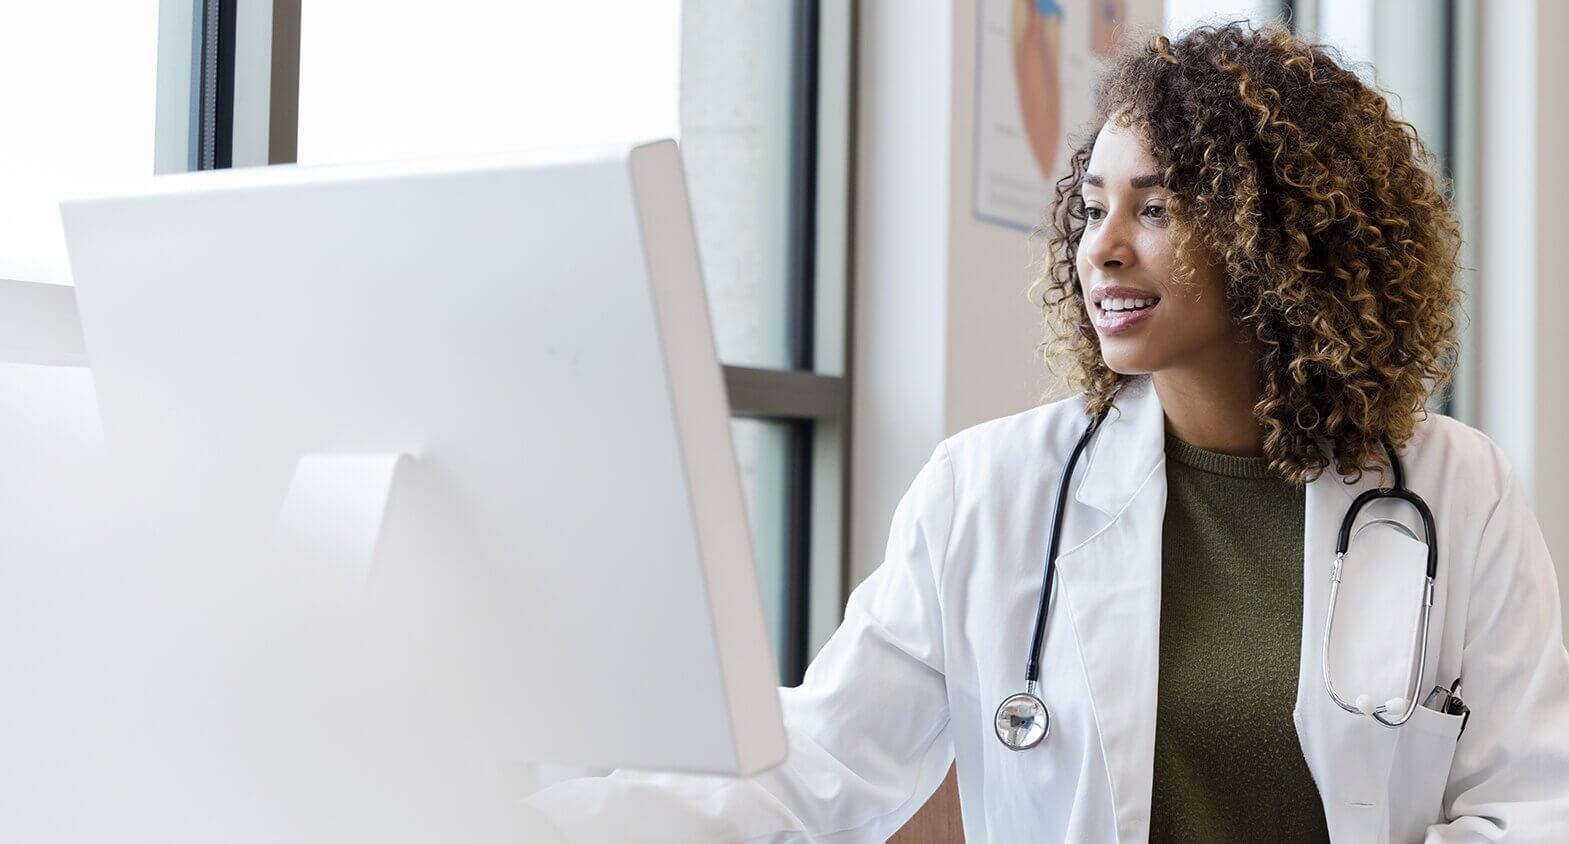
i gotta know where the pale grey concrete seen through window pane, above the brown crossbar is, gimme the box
[681,0,794,369]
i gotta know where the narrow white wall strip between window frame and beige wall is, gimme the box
[850,0,954,584]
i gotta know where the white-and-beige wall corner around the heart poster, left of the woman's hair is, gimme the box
[850,0,1161,584]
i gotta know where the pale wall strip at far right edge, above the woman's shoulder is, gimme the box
[1473,0,1569,618]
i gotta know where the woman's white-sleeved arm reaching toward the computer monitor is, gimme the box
[527,446,954,842]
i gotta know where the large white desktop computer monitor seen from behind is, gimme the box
[61,141,786,834]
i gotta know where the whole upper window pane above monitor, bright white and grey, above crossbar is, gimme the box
[298,0,794,369]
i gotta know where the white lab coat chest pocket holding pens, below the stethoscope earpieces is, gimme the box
[1389,706,1464,841]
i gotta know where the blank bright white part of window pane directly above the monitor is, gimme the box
[300,0,681,163]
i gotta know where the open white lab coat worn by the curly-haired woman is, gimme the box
[530,378,1569,844]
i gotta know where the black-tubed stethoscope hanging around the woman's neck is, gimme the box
[996,406,1439,750]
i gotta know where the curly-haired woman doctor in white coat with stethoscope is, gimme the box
[530,25,1569,844]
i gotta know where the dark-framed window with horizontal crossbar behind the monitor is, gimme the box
[158,0,854,686]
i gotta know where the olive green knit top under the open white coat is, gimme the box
[1150,433,1329,842]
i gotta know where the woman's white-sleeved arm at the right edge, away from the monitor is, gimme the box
[1426,447,1569,828]
